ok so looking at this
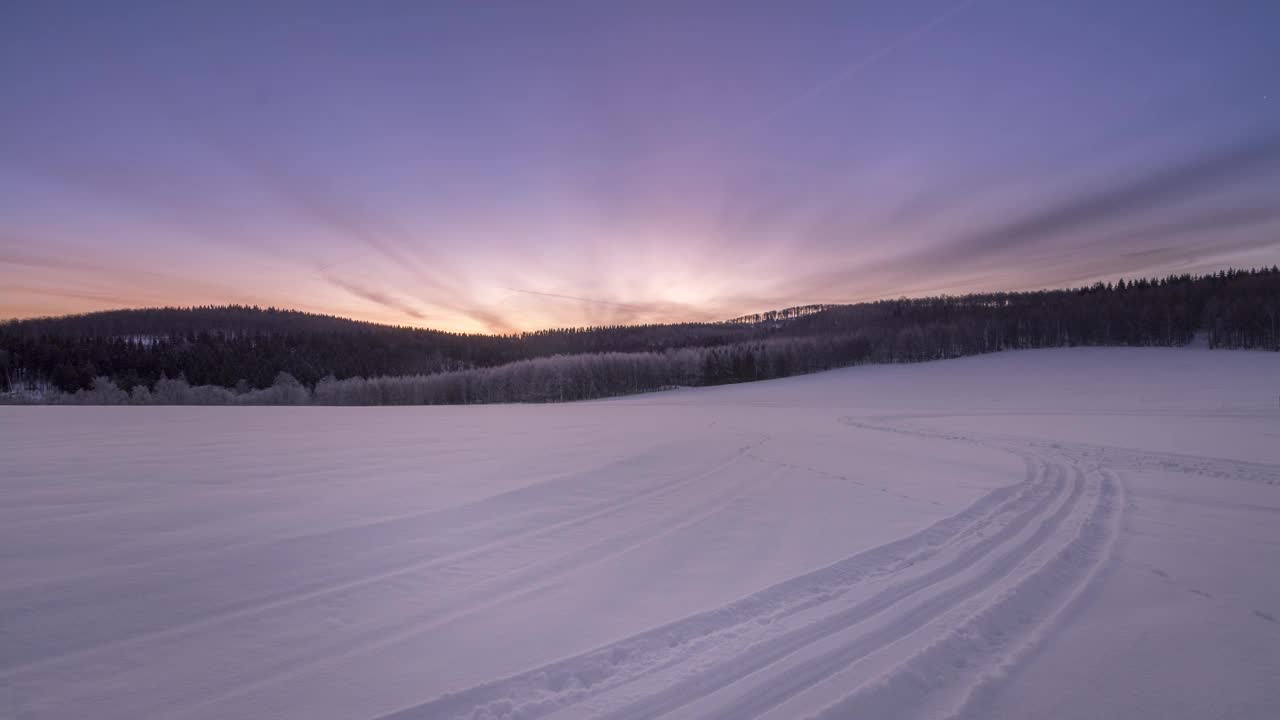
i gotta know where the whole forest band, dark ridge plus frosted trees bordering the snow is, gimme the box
[0,266,1280,405]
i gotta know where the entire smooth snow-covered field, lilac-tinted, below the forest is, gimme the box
[0,348,1280,720]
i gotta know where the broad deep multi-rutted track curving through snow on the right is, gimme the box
[378,418,1123,720]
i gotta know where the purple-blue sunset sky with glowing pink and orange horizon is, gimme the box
[0,0,1280,333]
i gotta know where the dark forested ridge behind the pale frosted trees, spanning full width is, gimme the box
[0,266,1280,398]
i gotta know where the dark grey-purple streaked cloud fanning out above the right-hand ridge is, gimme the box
[788,135,1280,300]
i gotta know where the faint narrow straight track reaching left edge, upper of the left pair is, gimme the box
[0,437,769,680]
